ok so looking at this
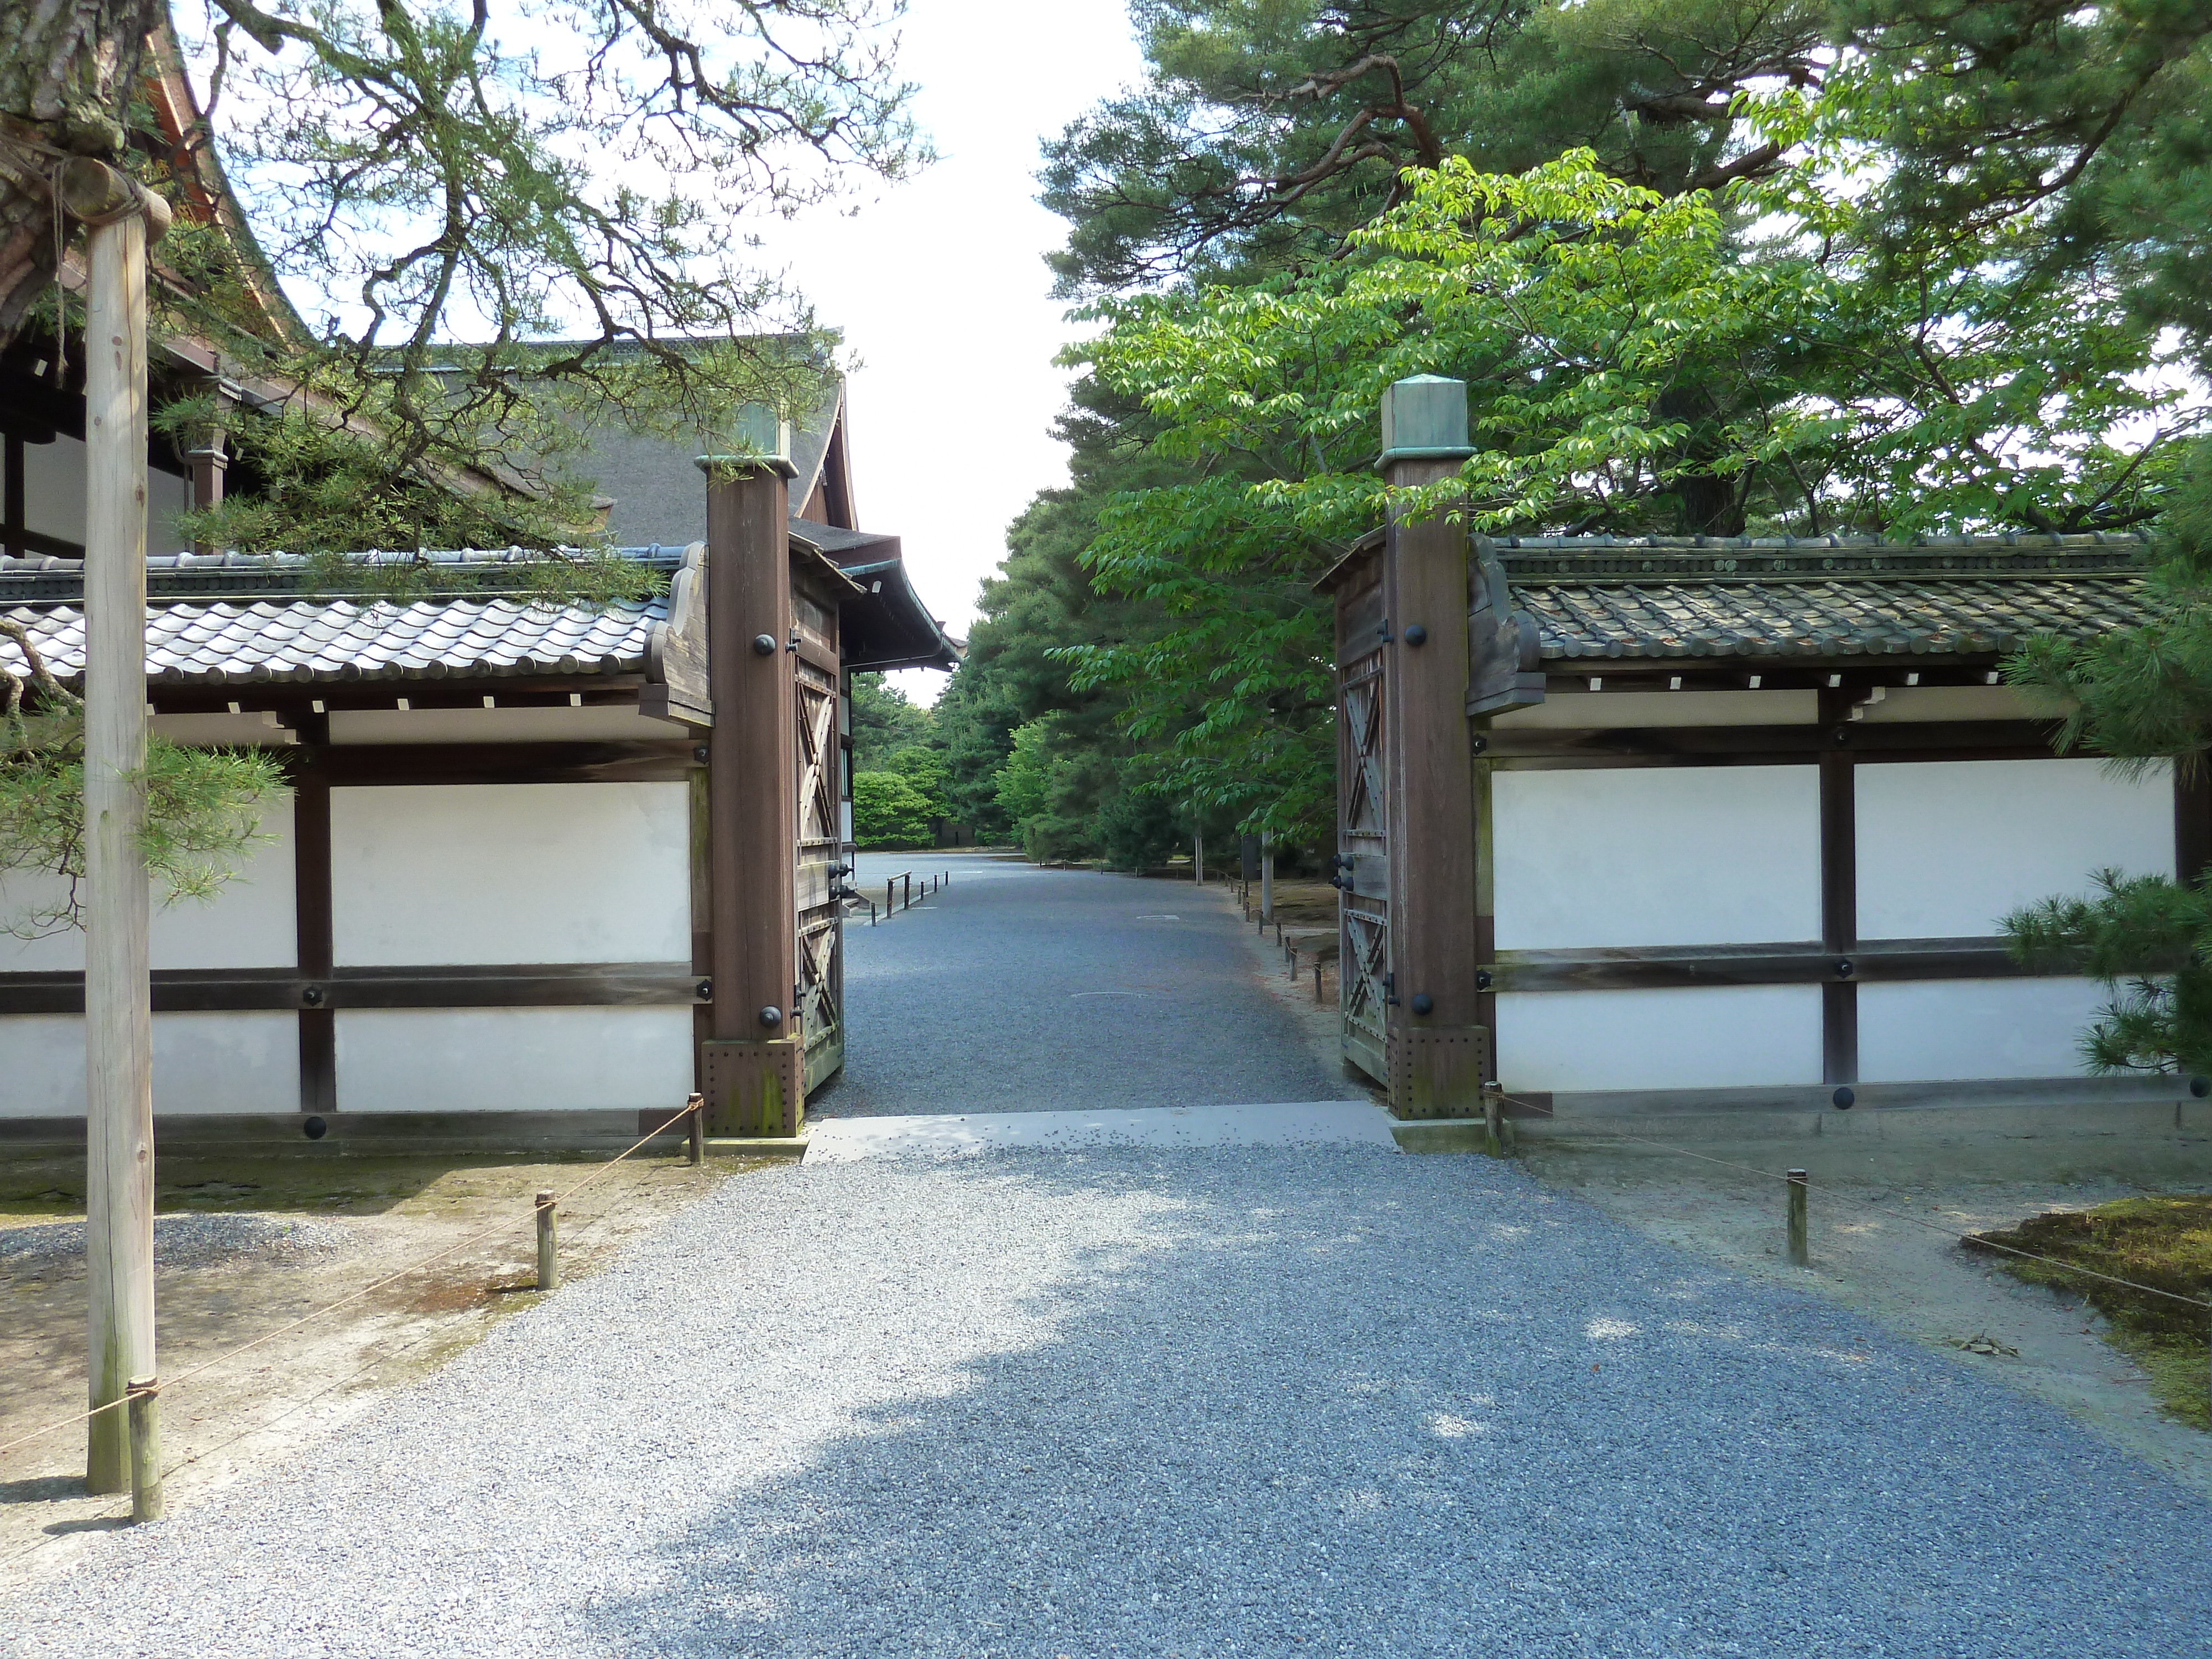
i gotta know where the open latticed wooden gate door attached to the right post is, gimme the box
[1336,549,1391,1084]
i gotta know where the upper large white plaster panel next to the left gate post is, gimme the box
[330,783,690,969]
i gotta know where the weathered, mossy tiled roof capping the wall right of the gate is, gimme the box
[1484,535,2152,659]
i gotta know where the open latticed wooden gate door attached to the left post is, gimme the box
[792,655,845,1095]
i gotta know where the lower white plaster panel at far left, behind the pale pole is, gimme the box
[0,1013,299,1117]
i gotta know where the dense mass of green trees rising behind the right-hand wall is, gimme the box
[945,0,2212,872]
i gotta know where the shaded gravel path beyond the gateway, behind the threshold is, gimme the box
[807,852,1363,1117]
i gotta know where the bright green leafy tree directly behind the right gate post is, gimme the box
[1057,142,2203,836]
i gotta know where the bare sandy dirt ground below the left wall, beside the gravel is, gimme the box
[0,1152,761,1588]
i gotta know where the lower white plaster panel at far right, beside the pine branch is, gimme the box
[1858,980,2106,1084]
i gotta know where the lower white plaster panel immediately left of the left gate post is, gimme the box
[336,1009,692,1113]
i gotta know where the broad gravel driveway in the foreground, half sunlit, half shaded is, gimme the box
[0,1150,2212,1659]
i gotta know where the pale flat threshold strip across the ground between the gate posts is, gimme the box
[805,1099,1398,1164]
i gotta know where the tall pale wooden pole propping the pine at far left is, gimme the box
[62,161,168,1493]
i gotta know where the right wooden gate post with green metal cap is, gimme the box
[1383,374,1489,1117]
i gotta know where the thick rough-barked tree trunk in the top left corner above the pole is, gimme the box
[0,0,168,347]
